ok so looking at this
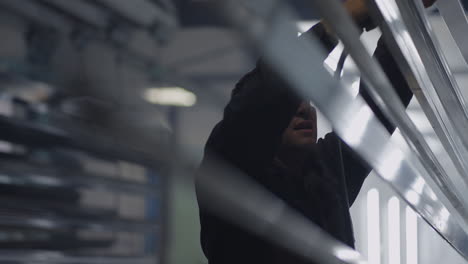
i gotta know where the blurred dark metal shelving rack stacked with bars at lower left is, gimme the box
[0,94,167,264]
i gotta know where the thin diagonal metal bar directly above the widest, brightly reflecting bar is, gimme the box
[313,0,468,237]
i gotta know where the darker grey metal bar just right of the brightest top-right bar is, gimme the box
[396,0,468,167]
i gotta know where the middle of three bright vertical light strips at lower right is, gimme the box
[388,196,400,264]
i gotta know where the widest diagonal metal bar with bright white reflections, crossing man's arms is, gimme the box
[220,0,468,258]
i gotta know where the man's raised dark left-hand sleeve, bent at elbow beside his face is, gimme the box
[205,23,337,176]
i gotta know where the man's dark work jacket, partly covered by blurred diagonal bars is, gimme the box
[197,24,412,264]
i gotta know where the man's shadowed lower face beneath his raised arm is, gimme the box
[282,102,317,149]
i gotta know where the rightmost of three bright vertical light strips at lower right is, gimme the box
[406,206,418,264]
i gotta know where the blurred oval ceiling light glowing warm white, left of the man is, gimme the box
[143,87,197,107]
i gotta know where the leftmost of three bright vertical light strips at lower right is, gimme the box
[367,189,380,264]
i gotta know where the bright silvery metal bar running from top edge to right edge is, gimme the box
[369,0,468,217]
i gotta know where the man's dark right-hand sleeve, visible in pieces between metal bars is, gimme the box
[341,39,413,206]
